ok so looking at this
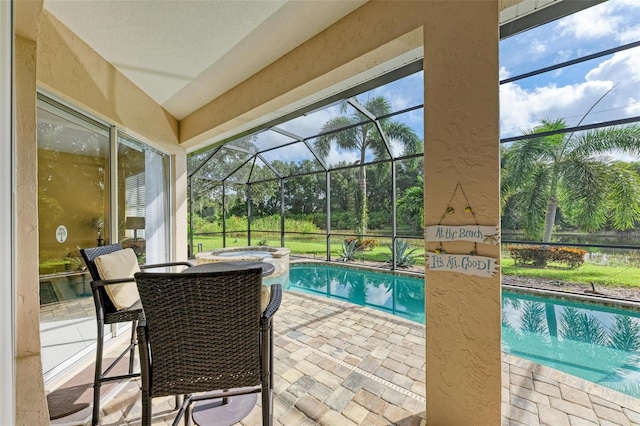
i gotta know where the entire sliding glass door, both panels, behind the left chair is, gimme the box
[38,96,171,380]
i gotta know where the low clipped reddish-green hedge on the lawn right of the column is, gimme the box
[507,246,587,269]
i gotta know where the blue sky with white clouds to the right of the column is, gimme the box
[500,0,640,137]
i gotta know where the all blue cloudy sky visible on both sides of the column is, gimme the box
[210,0,640,173]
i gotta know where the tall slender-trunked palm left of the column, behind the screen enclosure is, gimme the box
[314,96,422,235]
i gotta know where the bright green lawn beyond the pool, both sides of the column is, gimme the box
[194,233,640,288]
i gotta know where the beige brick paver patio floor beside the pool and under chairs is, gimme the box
[55,292,640,426]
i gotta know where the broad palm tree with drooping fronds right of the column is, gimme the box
[501,119,640,242]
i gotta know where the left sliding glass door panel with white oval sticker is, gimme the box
[37,101,111,377]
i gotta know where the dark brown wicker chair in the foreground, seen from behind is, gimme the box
[135,268,282,426]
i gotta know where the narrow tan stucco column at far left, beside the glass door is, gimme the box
[15,36,49,425]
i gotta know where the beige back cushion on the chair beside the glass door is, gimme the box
[95,248,140,310]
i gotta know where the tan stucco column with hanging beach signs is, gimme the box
[424,0,501,426]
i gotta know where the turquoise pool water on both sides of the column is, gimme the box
[285,265,640,398]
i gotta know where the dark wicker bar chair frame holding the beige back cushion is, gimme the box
[80,244,191,425]
